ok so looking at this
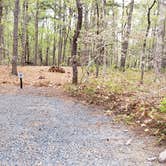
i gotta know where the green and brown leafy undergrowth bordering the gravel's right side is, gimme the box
[65,70,166,143]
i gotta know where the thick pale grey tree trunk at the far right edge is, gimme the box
[154,0,166,80]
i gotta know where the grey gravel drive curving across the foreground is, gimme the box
[0,95,163,166]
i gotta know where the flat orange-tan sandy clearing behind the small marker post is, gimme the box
[0,66,71,87]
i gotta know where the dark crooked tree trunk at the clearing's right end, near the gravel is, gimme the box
[71,0,83,84]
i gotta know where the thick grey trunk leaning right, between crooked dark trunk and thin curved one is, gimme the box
[120,0,134,71]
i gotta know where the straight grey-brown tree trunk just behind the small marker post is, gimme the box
[12,0,20,75]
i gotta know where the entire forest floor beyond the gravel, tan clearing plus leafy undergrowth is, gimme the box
[0,66,166,145]
